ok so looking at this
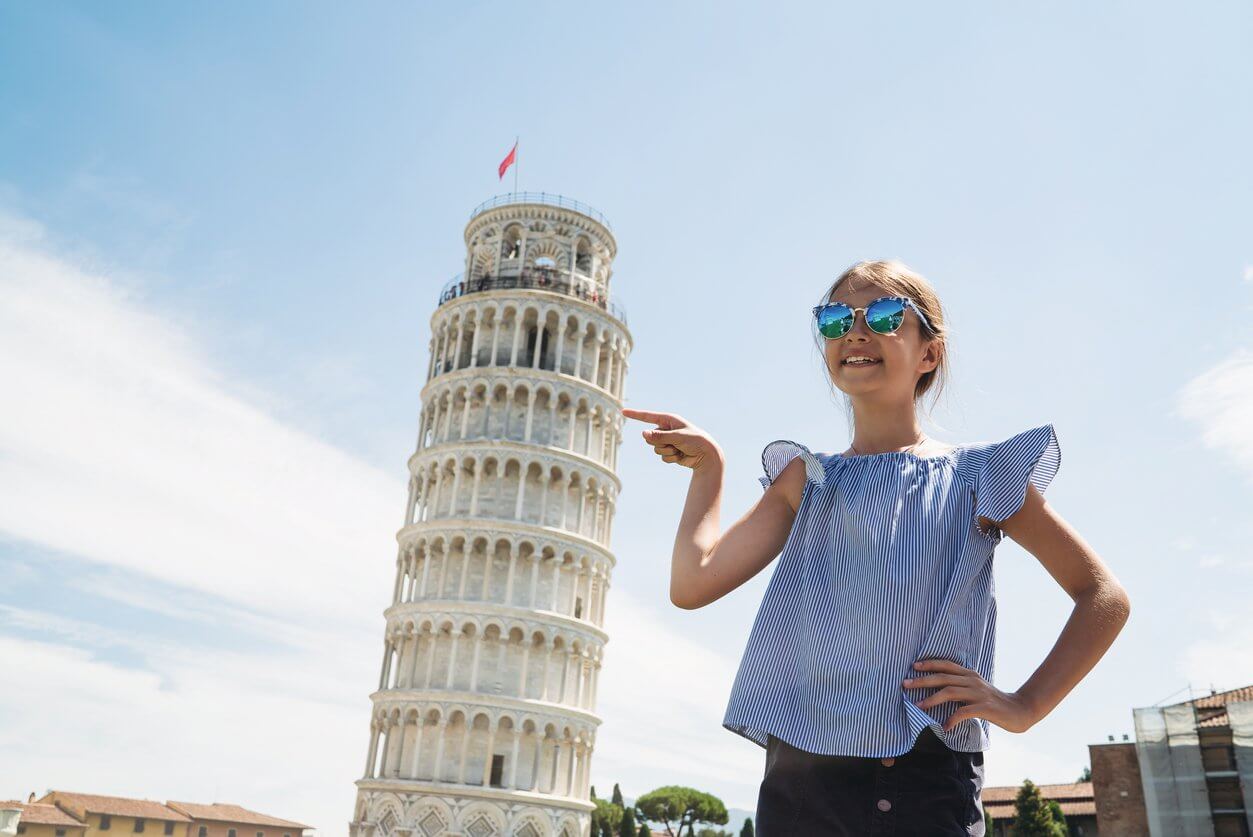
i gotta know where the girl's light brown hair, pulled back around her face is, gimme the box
[813,259,949,427]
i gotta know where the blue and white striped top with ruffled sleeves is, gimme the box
[722,425,1061,758]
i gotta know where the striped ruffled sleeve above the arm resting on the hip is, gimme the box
[974,424,1061,536]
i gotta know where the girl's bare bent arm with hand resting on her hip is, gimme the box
[903,482,1131,732]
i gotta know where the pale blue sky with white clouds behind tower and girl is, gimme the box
[0,1,1253,834]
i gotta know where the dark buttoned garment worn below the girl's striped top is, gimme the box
[757,727,985,837]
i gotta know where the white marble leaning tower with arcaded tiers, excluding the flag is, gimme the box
[351,193,632,837]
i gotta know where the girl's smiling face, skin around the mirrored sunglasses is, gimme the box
[823,282,940,400]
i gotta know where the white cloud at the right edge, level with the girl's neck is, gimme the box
[1175,350,1253,479]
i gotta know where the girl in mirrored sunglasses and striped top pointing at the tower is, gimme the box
[623,261,1130,837]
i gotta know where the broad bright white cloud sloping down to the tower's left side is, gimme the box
[0,225,403,626]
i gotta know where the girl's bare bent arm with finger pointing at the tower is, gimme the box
[623,408,806,610]
